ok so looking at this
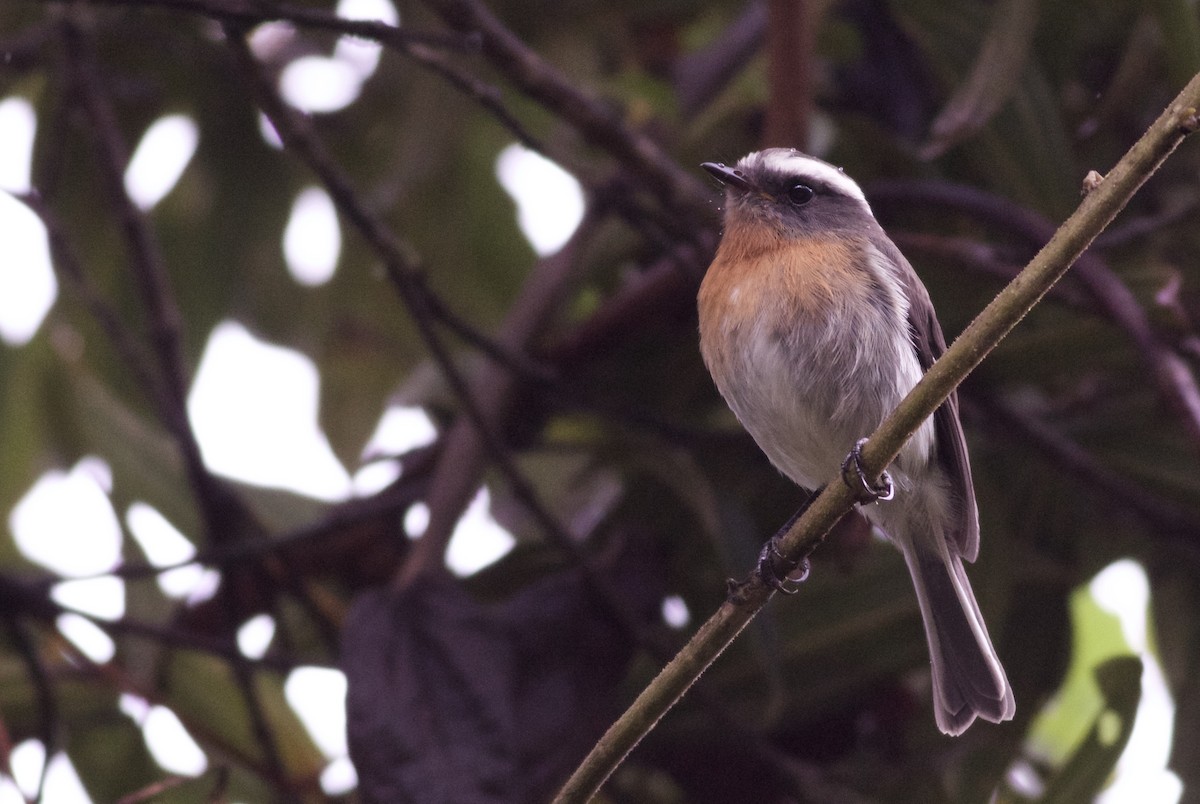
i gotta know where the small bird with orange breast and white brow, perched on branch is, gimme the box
[698,148,1015,734]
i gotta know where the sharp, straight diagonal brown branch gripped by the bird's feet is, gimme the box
[556,74,1200,803]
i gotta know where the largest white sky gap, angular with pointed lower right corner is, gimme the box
[187,322,350,500]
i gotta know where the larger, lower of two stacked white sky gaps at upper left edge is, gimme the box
[0,192,59,346]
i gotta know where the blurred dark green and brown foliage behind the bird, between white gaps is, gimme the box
[0,0,1200,803]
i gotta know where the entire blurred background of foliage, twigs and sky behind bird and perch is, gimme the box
[0,0,1200,804]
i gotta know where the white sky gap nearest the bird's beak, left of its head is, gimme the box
[496,143,583,256]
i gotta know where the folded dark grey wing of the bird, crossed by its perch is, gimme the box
[888,240,979,562]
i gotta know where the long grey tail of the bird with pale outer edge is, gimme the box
[901,542,1016,734]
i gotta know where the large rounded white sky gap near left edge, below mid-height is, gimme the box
[8,458,121,577]
